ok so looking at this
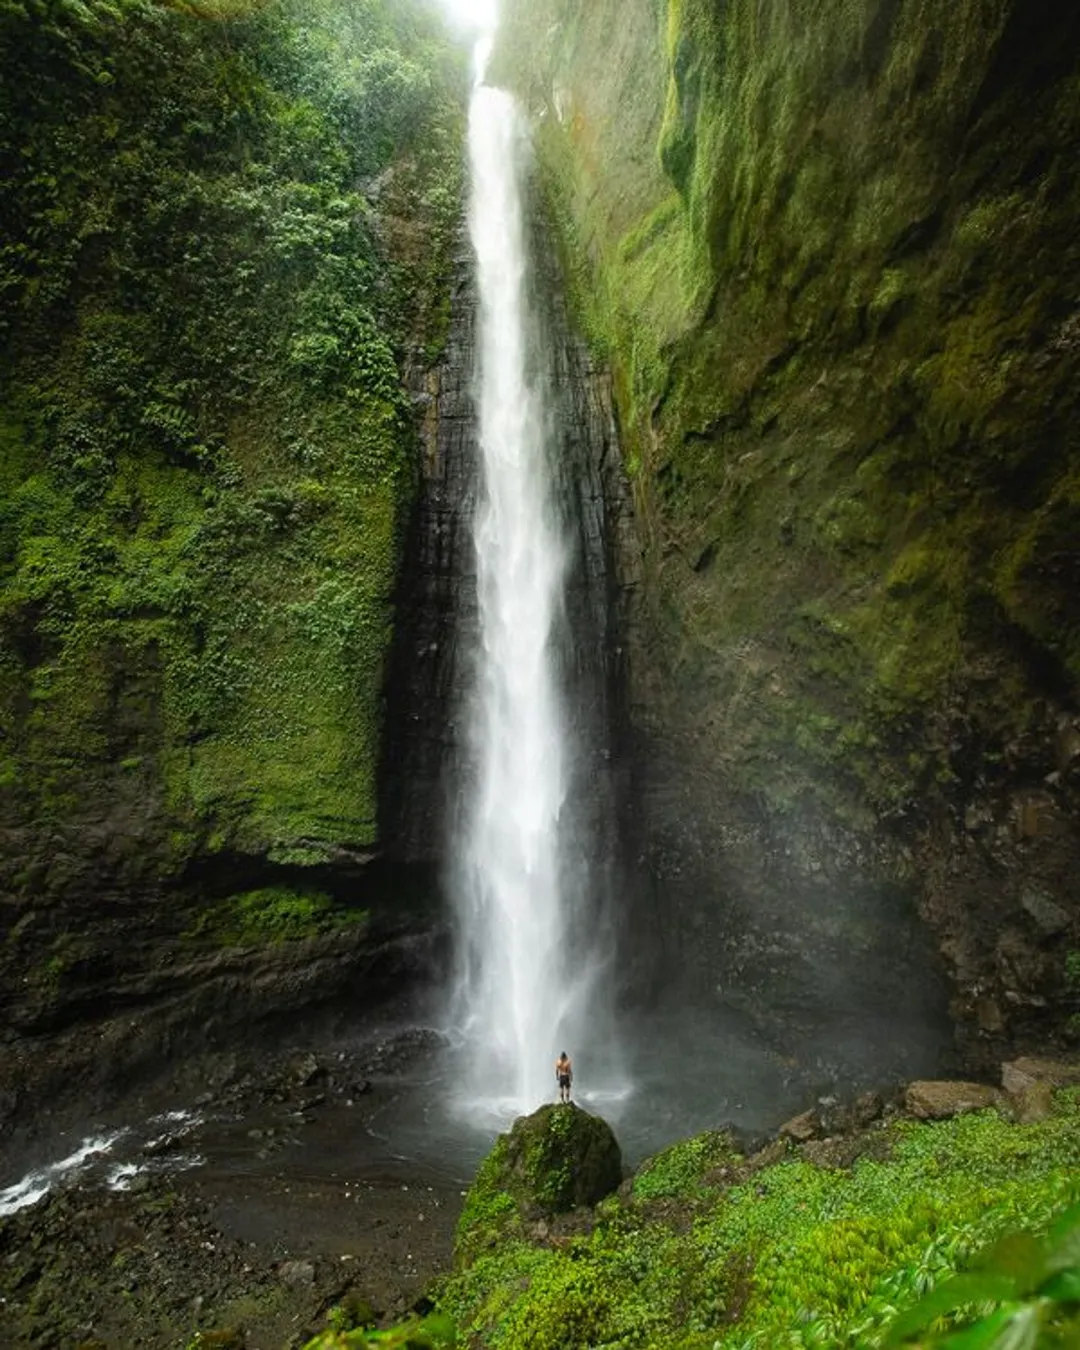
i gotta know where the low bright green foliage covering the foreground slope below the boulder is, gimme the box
[439,1091,1080,1350]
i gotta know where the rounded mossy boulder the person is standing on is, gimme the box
[455,1104,622,1266]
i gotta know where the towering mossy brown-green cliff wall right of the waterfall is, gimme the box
[500,0,1080,1057]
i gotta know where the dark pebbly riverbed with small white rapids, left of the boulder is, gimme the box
[0,1030,466,1350]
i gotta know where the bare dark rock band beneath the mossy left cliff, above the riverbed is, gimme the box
[0,911,437,1138]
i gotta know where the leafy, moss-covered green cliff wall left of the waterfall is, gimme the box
[0,0,466,1085]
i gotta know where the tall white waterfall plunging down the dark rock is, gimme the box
[455,71,589,1112]
